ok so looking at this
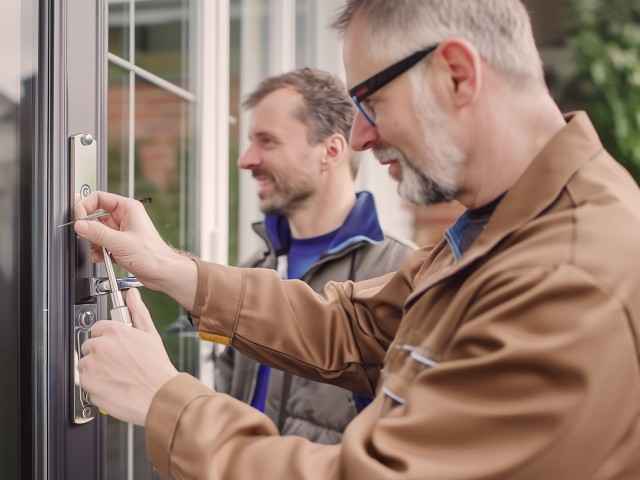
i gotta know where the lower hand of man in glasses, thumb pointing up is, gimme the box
[78,289,178,426]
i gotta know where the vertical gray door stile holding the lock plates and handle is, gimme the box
[45,0,106,479]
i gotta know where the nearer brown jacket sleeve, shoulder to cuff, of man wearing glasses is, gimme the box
[146,267,640,480]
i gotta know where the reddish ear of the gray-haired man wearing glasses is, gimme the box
[436,38,482,108]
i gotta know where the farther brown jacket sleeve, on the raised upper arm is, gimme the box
[192,255,422,395]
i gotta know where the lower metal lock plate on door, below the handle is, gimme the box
[73,303,98,425]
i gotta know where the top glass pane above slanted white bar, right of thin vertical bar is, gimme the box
[135,0,192,90]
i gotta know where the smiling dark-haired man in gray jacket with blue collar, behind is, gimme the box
[215,68,412,444]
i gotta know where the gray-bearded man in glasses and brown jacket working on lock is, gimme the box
[76,0,640,480]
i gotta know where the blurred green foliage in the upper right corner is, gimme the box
[565,0,640,183]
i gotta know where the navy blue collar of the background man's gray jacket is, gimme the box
[253,191,384,256]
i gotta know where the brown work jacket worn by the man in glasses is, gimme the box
[146,113,640,480]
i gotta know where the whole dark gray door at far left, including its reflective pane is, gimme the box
[0,0,104,479]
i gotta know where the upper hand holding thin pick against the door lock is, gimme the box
[74,192,196,300]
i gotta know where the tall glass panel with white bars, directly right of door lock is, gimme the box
[105,0,199,474]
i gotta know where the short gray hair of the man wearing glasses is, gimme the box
[333,0,544,83]
